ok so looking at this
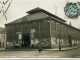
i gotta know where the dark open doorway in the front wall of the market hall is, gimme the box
[22,33,31,47]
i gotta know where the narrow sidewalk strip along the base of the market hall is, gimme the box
[0,46,80,51]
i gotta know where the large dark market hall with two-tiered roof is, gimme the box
[5,7,80,48]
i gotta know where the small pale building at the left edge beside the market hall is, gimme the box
[0,27,6,48]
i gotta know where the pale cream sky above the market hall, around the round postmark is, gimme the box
[0,0,80,28]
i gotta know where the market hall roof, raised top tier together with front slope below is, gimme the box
[5,7,66,25]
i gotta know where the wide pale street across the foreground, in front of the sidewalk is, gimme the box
[0,46,80,58]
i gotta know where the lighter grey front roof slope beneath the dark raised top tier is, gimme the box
[5,12,49,24]
